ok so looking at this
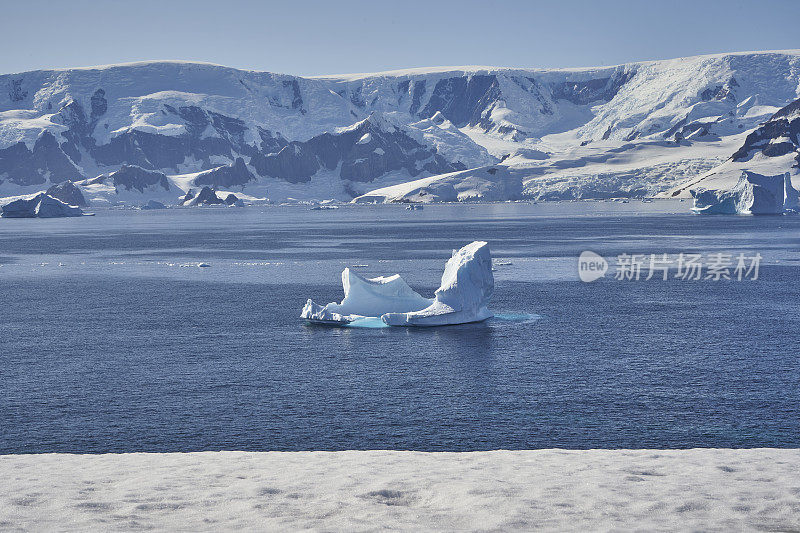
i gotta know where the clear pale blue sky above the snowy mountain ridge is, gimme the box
[6,0,800,75]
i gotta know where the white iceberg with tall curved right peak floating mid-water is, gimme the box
[300,241,494,326]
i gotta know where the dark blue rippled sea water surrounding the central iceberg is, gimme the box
[0,201,800,454]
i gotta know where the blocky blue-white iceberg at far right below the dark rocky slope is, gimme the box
[689,170,798,215]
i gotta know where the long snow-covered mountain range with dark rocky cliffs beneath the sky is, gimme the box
[0,51,800,203]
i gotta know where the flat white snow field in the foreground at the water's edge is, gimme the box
[0,449,800,531]
